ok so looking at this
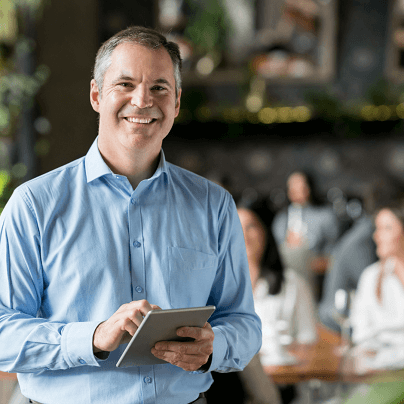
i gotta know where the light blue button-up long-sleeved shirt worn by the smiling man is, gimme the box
[0,140,261,404]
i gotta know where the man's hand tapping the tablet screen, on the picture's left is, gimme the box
[93,300,160,353]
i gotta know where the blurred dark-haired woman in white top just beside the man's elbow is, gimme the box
[238,201,317,365]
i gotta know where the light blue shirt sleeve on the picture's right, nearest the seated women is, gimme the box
[208,195,262,372]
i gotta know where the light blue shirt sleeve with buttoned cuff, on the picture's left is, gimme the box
[0,188,99,373]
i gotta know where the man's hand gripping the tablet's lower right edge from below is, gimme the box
[151,323,215,371]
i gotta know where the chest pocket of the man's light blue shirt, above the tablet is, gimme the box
[168,247,217,308]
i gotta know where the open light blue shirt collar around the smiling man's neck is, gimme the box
[85,136,168,183]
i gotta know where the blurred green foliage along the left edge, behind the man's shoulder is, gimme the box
[0,0,49,213]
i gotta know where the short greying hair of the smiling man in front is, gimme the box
[93,26,182,97]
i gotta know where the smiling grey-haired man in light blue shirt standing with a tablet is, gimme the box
[0,27,261,404]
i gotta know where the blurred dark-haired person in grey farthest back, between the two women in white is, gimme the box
[272,171,341,294]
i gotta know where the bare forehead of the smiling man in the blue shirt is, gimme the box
[106,42,174,81]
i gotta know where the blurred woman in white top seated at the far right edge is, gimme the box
[350,203,404,348]
